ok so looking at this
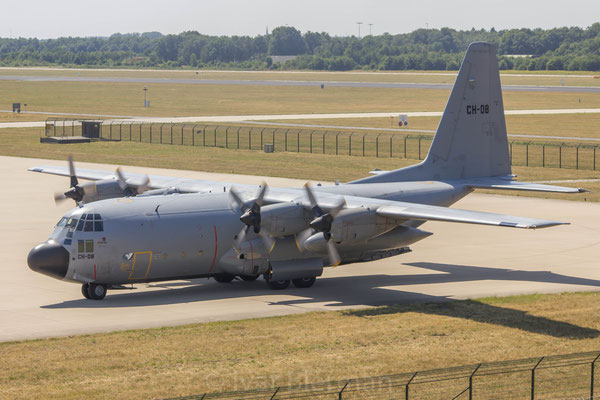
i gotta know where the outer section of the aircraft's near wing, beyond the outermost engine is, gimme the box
[377,204,568,229]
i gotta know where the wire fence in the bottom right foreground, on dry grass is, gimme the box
[168,351,600,400]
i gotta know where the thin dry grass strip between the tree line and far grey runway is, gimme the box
[0,68,600,86]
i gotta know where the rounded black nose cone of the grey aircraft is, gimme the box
[27,240,69,279]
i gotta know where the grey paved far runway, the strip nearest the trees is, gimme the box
[0,75,600,93]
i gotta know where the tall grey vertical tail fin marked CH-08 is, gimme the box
[360,42,511,183]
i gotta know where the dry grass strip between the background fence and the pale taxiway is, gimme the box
[0,129,600,201]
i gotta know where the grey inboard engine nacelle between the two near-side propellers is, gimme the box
[260,203,308,237]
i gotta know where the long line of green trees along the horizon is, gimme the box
[0,23,600,71]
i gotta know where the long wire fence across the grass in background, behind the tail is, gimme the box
[42,119,600,171]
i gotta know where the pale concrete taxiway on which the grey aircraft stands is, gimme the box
[0,157,600,341]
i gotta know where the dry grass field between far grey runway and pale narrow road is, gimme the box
[0,77,600,121]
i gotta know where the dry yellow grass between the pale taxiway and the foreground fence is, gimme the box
[0,293,600,399]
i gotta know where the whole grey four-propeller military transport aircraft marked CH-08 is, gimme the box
[27,43,583,300]
